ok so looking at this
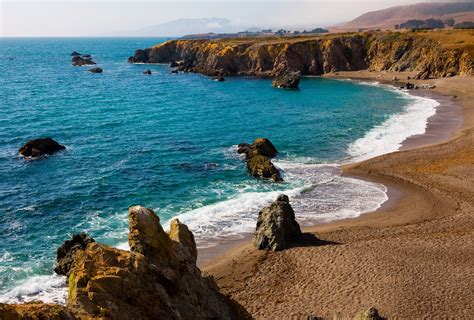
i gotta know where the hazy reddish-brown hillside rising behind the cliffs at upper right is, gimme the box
[330,2,474,31]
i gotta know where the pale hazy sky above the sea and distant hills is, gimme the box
[0,0,466,37]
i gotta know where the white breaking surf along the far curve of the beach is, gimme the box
[347,86,439,162]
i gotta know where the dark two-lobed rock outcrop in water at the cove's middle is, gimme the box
[237,138,283,182]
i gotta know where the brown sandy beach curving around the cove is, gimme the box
[202,71,474,319]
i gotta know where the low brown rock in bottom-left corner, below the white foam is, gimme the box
[0,302,77,320]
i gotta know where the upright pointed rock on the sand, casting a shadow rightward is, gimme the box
[253,194,302,251]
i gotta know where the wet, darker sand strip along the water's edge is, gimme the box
[197,75,463,267]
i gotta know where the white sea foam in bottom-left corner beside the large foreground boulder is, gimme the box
[0,275,67,304]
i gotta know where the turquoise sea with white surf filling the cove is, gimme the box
[0,38,436,301]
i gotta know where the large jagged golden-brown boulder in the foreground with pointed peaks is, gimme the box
[67,206,250,319]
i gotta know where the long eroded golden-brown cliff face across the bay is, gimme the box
[129,32,474,77]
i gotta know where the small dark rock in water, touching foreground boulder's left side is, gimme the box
[54,232,94,276]
